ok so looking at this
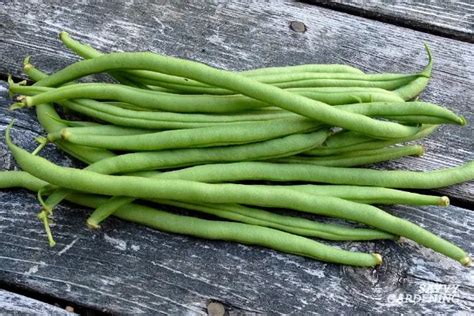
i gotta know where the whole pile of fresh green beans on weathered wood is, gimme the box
[0,32,474,267]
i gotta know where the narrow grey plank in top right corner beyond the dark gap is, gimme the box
[305,0,474,43]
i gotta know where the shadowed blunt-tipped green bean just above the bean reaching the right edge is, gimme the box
[274,145,424,167]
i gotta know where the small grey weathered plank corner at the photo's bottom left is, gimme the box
[0,289,77,316]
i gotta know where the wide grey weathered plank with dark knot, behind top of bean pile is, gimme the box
[0,1,474,203]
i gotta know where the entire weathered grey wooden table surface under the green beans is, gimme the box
[0,0,474,315]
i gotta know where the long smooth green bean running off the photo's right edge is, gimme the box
[160,161,474,189]
